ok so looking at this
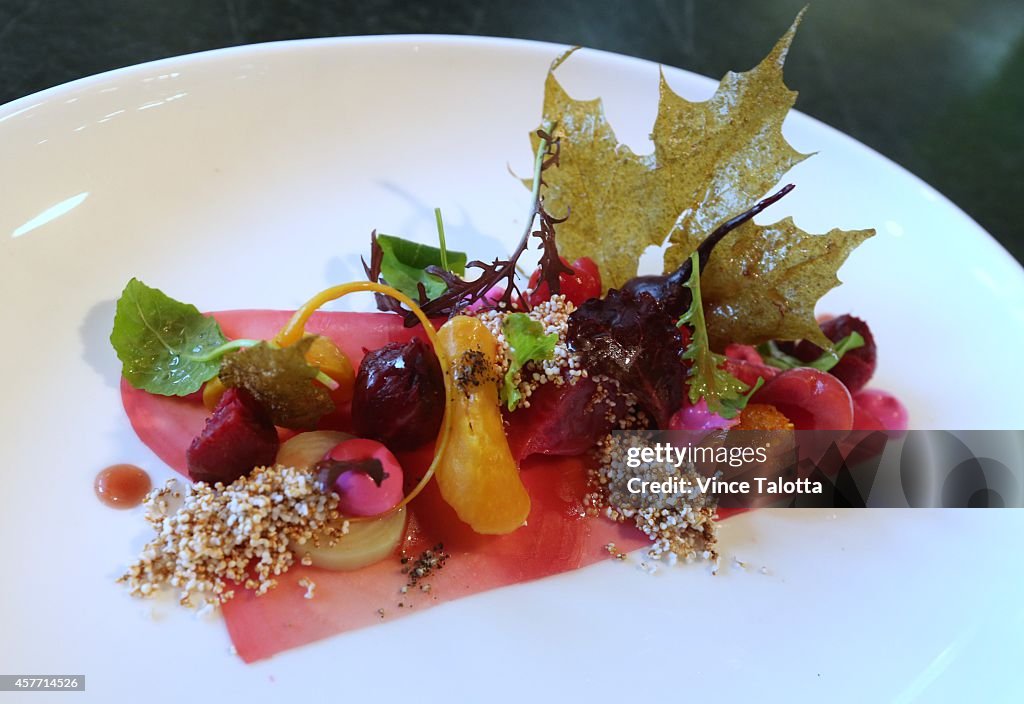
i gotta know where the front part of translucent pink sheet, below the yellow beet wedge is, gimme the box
[223,455,649,662]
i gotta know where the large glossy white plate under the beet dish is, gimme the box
[0,37,1024,702]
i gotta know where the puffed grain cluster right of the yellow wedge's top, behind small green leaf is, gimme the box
[468,294,587,408]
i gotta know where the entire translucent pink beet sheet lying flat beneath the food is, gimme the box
[122,311,688,662]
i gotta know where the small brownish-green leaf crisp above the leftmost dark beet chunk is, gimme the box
[220,337,334,430]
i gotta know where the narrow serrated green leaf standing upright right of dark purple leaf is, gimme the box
[679,252,757,419]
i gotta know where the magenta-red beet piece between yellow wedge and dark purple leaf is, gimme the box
[505,378,615,460]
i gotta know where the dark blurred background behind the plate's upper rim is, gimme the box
[0,0,1024,261]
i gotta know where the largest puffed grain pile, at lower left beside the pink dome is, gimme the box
[118,465,347,608]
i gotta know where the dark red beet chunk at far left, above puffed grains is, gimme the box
[185,389,280,484]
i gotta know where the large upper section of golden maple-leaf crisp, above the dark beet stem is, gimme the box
[535,13,805,288]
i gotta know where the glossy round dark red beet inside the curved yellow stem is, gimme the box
[352,338,444,450]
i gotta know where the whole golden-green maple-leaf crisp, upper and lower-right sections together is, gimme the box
[527,12,873,349]
